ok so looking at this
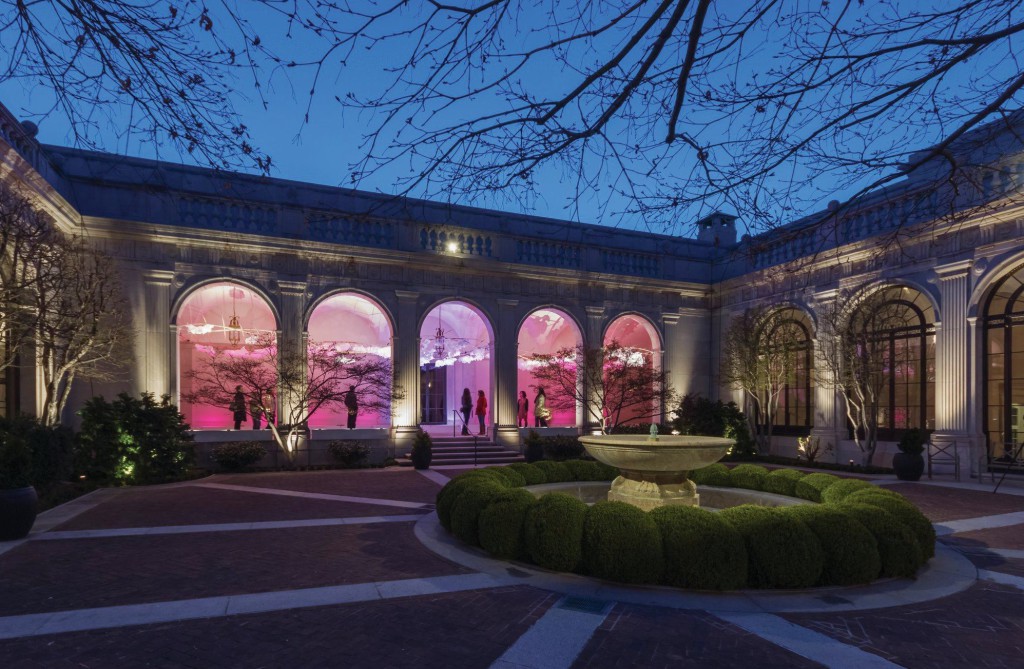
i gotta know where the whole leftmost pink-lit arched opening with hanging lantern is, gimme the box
[175,281,278,429]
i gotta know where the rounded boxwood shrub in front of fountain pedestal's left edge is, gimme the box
[583,502,663,583]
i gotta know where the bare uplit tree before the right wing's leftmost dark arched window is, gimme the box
[721,306,806,453]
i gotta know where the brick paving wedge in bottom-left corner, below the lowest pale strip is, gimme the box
[0,587,557,669]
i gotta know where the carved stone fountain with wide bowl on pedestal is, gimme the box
[580,425,736,511]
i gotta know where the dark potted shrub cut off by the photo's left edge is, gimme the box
[0,429,39,541]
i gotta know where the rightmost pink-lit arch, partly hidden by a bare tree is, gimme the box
[602,313,663,425]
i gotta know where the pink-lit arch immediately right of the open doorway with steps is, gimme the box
[516,308,583,427]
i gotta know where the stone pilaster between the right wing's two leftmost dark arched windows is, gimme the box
[811,290,847,462]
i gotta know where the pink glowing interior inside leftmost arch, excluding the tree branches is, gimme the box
[176,281,278,430]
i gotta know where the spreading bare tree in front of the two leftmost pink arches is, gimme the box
[181,333,404,457]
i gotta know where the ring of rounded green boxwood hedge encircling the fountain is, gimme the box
[436,461,935,590]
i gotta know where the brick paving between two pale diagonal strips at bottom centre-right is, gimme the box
[572,604,821,669]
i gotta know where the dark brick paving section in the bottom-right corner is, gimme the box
[784,583,1024,669]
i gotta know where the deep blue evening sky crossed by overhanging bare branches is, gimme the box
[0,0,1024,232]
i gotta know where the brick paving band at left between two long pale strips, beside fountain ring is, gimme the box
[0,522,467,616]
